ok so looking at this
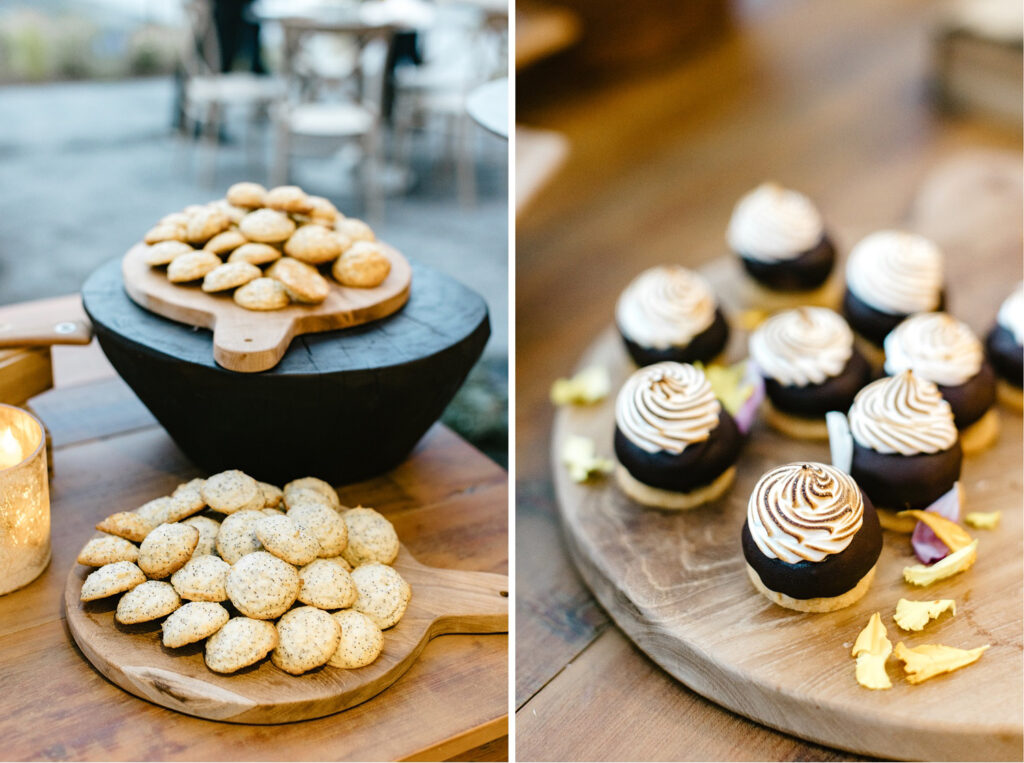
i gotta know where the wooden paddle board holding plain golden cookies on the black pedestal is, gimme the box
[122,244,413,373]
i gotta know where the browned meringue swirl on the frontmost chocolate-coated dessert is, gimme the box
[746,461,864,564]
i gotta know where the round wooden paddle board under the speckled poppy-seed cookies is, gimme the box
[65,547,508,724]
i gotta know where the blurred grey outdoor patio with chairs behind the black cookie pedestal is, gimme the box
[0,0,509,465]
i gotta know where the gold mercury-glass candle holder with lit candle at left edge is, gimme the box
[0,404,50,595]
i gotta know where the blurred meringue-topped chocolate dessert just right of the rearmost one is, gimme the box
[843,230,945,367]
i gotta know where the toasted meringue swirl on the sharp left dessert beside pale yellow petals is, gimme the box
[615,361,722,455]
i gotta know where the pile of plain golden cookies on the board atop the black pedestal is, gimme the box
[143,182,391,310]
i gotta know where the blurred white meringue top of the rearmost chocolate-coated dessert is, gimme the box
[726,182,824,262]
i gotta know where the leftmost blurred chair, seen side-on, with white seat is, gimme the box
[181,0,285,186]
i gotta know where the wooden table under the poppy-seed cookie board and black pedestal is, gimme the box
[0,296,508,760]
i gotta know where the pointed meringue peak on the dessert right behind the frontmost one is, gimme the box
[850,371,957,456]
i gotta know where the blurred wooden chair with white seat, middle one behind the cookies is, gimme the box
[270,22,394,221]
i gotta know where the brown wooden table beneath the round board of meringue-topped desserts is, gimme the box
[516,0,1021,760]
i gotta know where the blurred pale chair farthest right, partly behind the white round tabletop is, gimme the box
[393,4,505,205]
